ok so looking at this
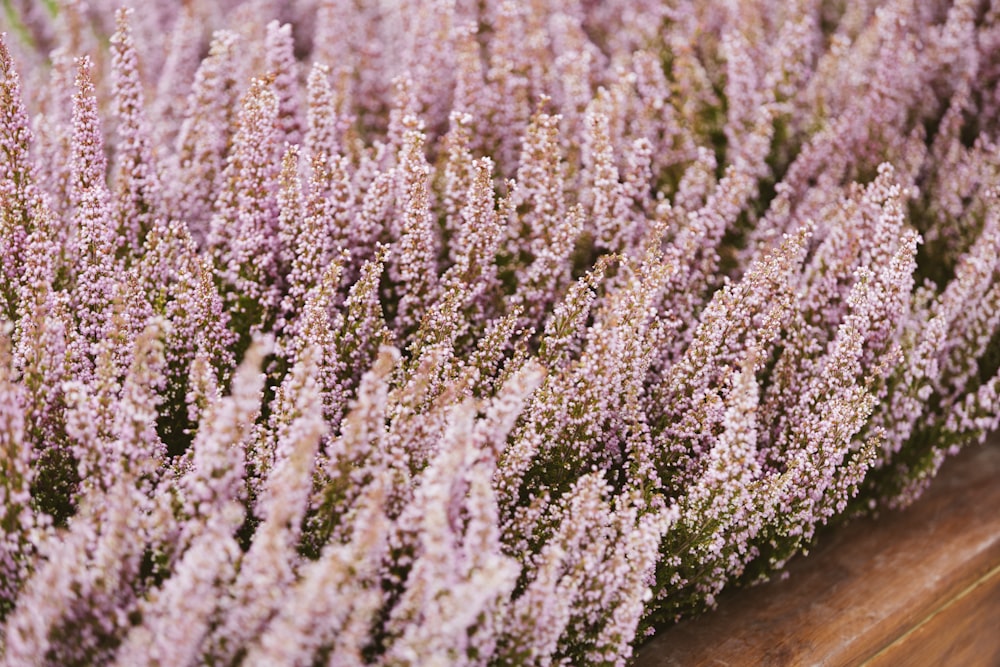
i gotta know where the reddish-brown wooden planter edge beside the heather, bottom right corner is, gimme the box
[635,443,1000,667]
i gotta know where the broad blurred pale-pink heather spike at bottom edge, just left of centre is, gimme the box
[387,403,519,664]
